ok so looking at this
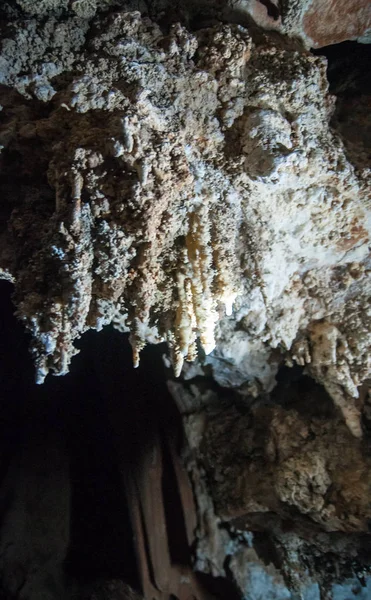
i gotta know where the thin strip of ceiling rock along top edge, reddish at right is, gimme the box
[0,0,371,48]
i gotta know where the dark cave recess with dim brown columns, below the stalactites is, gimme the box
[0,281,247,600]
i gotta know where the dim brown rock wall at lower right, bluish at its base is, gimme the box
[169,378,370,600]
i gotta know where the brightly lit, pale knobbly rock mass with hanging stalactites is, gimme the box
[1,12,371,436]
